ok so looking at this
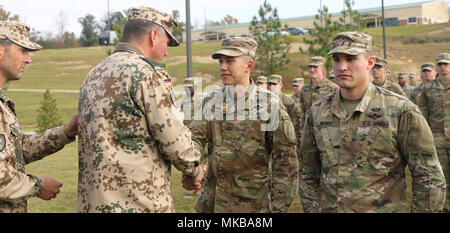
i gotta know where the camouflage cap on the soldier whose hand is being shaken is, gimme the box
[212,37,258,59]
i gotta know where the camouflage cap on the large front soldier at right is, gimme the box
[327,32,372,56]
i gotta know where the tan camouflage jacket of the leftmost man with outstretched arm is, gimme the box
[0,90,74,213]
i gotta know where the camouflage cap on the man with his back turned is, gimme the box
[128,7,180,47]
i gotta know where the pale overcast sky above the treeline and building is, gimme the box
[0,0,449,36]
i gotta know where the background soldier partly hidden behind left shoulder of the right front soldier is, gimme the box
[300,57,339,125]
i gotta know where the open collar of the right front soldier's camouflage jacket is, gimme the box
[331,82,376,119]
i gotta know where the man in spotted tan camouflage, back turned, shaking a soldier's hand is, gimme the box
[77,7,203,213]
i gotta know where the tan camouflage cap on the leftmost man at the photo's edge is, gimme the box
[0,21,42,51]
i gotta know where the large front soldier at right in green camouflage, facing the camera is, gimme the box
[300,32,445,213]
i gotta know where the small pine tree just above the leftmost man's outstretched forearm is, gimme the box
[37,89,62,133]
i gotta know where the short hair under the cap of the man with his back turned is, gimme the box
[122,19,165,42]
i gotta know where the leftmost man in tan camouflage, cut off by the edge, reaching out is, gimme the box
[0,21,77,212]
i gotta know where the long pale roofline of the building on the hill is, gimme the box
[198,0,436,32]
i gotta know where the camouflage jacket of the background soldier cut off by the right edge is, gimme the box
[417,78,450,149]
